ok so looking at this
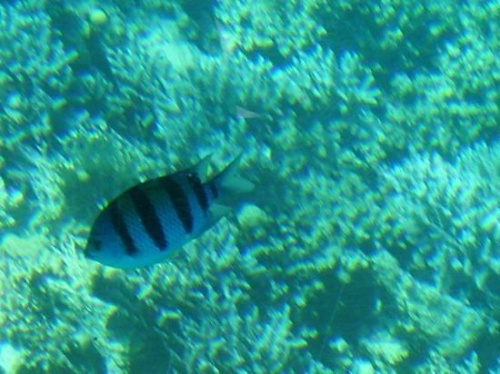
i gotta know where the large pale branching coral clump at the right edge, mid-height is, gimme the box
[380,143,500,297]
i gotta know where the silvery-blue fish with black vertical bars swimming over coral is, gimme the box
[84,155,253,269]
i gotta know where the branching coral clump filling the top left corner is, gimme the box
[0,1,72,155]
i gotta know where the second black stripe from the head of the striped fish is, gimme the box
[130,187,167,250]
